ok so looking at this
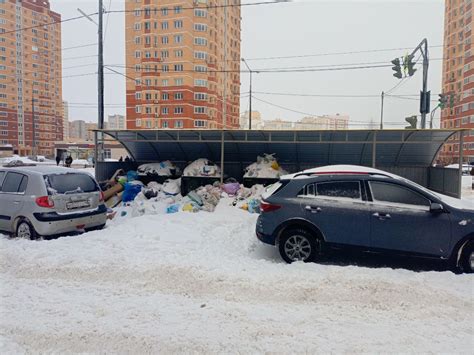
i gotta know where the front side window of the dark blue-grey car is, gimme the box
[370,181,431,206]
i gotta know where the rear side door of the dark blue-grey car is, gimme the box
[299,180,370,246]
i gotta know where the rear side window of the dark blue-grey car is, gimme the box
[303,181,361,200]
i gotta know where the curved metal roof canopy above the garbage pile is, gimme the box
[97,129,463,171]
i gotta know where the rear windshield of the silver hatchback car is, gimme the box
[45,173,99,195]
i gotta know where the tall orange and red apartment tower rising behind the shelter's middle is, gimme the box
[125,0,241,129]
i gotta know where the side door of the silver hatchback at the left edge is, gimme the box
[0,172,28,232]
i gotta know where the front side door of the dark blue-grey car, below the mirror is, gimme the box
[369,181,451,256]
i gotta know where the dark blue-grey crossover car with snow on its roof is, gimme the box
[256,165,474,273]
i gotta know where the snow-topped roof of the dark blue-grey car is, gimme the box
[281,165,403,180]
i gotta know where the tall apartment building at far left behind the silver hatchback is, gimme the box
[0,0,63,155]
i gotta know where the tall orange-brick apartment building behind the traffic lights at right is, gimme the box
[440,0,474,163]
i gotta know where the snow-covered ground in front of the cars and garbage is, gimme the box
[0,199,474,354]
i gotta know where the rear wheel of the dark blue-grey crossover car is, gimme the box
[278,229,322,264]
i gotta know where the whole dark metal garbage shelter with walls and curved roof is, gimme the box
[95,129,464,197]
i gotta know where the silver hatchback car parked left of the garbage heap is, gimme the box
[0,166,107,239]
